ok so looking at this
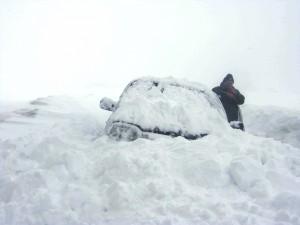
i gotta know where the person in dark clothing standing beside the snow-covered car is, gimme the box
[212,74,245,131]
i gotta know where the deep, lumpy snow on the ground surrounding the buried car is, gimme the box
[0,90,300,225]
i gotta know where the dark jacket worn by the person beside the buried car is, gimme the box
[212,85,245,122]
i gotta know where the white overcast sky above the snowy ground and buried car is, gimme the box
[0,0,300,100]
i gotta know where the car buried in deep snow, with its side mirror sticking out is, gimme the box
[100,78,229,141]
